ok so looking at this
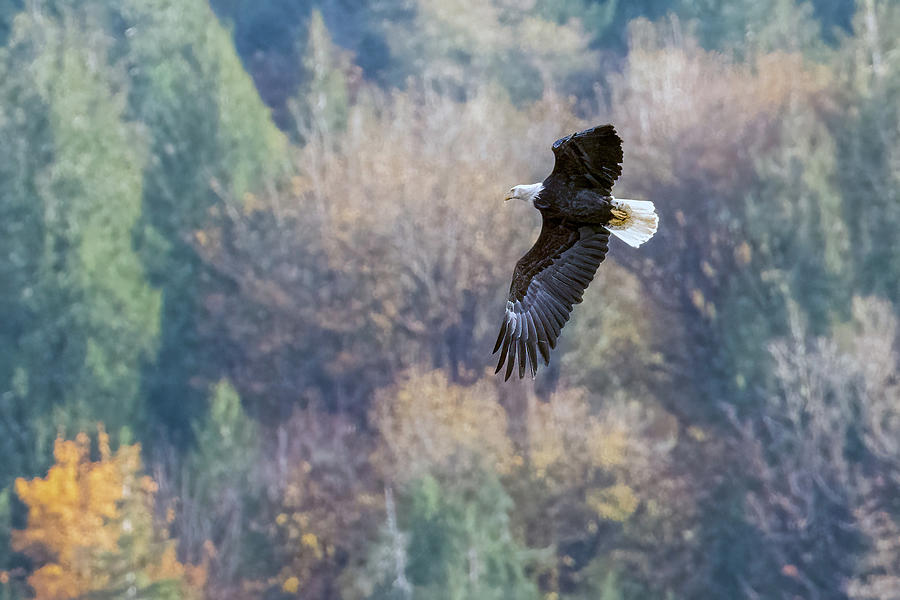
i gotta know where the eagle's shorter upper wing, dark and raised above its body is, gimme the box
[550,125,623,196]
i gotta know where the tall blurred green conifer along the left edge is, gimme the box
[0,7,159,488]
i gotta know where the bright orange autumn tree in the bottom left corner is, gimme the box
[12,425,205,600]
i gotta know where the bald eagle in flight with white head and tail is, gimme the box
[494,125,658,380]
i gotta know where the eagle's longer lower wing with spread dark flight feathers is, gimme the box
[494,218,609,380]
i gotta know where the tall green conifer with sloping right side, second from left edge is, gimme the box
[114,0,284,441]
